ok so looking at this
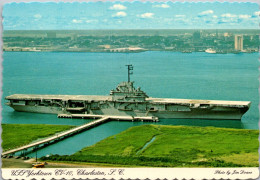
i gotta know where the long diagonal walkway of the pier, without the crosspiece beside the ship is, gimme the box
[2,117,109,156]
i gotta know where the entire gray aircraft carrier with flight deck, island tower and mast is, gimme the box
[5,65,250,120]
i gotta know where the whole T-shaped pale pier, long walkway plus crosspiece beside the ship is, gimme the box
[2,114,158,156]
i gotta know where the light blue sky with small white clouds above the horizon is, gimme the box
[3,1,260,30]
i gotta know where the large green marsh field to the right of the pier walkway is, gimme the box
[41,125,259,167]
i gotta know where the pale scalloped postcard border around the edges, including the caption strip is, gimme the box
[0,0,260,180]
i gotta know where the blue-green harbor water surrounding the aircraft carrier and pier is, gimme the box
[2,52,259,156]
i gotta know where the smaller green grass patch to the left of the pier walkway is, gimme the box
[2,124,74,151]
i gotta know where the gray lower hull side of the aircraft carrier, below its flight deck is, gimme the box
[11,105,246,120]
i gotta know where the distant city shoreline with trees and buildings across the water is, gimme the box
[3,29,259,54]
